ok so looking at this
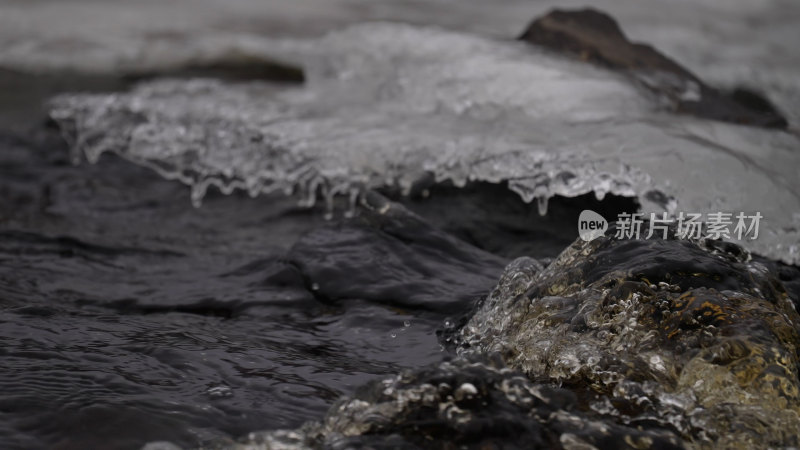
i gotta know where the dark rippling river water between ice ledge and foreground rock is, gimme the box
[0,118,635,449]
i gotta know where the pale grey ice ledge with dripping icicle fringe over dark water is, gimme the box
[50,23,800,263]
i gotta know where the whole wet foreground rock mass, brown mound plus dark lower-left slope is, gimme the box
[208,223,800,449]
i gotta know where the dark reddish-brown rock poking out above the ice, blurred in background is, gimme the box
[520,9,788,129]
